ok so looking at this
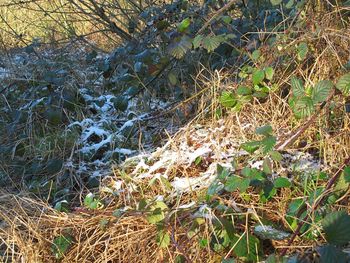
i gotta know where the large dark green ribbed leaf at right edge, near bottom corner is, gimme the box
[322,211,350,246]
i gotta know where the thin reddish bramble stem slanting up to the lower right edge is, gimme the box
[280,158,350,257]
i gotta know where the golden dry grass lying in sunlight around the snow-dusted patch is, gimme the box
[0,5,350,262]
